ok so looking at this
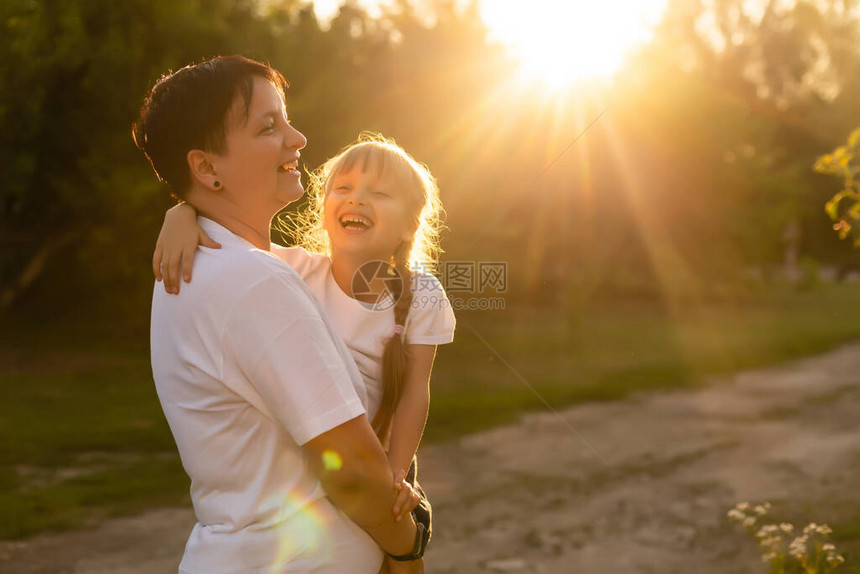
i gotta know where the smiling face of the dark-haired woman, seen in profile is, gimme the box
[212,77,307,210]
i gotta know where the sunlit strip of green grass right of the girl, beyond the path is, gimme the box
[427,285,860,441]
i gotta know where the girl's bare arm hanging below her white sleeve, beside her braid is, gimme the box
[388,345,436,486]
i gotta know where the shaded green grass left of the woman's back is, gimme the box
[0,356,188,538]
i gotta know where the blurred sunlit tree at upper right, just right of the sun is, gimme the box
[624,0,858,280]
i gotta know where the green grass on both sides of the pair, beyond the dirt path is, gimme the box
[5,285,860,538]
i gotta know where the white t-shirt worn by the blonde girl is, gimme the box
[272,245,456,420]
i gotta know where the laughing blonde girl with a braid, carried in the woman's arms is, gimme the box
[153,133,455,572]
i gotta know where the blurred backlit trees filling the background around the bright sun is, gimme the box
[0,0,860,332]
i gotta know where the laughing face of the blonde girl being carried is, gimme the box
[323,161,417,261]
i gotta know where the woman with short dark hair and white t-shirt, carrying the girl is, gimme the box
[134,56,425,574]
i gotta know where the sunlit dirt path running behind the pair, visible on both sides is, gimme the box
[0,344,860,574]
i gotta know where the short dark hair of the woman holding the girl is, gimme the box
[132,56,289,197]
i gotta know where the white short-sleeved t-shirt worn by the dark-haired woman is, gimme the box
[151,217,382,574]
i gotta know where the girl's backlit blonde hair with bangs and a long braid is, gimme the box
[287,132,444,440]
